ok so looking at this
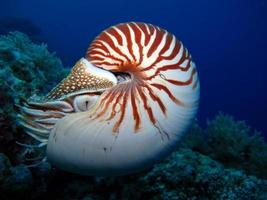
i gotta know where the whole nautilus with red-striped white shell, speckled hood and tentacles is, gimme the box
[20,22,200,175]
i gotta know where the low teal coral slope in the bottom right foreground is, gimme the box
[141,149,267,199]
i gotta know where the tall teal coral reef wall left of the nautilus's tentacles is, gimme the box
[0,32,68,161]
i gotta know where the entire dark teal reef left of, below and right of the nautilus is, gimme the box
[0,32,267,200]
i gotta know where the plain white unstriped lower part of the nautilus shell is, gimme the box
[47,81,199,176]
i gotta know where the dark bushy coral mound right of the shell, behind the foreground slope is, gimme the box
[182,112,267,178]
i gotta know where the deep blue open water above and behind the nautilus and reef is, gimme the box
[0,0,267,133]
